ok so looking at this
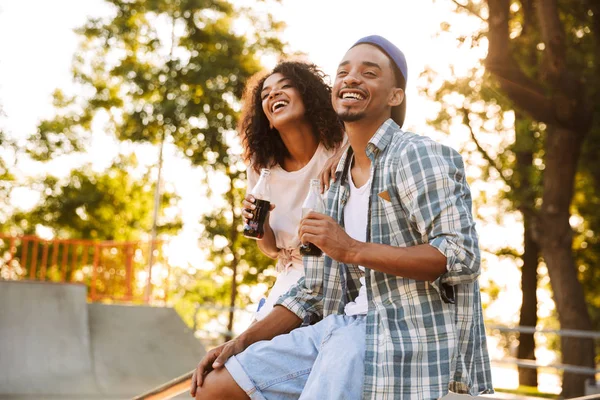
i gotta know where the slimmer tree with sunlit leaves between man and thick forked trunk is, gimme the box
[422,59,541,386]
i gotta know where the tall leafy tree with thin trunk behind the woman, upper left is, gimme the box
[23,0,283,334]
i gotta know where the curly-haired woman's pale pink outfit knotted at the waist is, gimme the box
[247,144,334,320]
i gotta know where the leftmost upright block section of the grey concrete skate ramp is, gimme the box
[0,282,97,397]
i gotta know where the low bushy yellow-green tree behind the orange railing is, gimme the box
[0,156,181,298]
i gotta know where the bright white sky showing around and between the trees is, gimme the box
[0,0,564,392]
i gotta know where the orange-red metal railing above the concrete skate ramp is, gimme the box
[0,233,170,303]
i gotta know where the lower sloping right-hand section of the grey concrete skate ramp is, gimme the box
[89,304,204,397]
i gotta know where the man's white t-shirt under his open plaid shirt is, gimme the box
[344,161,371,315]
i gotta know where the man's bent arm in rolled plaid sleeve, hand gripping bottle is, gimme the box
[300,142,479,289]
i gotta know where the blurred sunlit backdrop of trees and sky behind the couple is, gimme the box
[0,0,600,396]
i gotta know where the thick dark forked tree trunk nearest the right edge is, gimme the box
[486,0,594,397]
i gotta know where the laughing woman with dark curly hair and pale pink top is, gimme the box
[240,61,345,320]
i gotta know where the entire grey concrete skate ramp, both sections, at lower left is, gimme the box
[0,281,204,400]
